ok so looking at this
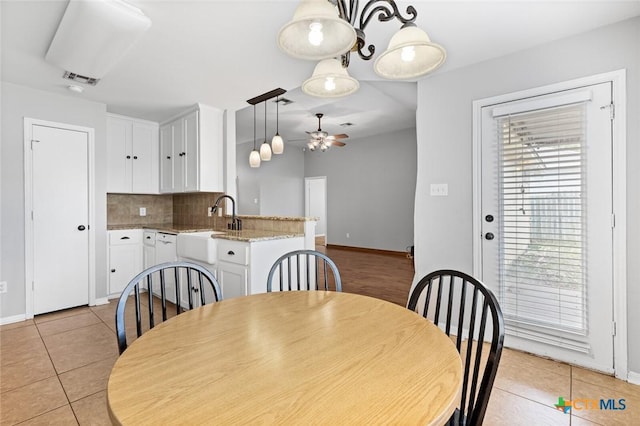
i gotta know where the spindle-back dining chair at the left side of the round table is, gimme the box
[116,261,222,354]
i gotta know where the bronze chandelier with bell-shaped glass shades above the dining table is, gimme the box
[278,0,446,97]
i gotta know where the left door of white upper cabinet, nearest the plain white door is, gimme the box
[107,117,132,193]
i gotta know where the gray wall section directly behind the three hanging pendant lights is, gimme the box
[236,142,304,216]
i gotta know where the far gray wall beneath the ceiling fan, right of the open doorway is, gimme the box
[305,128,416,251]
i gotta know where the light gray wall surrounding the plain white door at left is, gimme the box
[0,83,107,318]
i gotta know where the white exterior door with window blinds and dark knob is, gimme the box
[480,82,614,372]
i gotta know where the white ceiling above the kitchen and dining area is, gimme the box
[0,0,640,143]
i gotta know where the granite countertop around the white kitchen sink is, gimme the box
[107,224,304,242]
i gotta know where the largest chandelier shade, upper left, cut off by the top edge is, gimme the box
[278,0,356,60]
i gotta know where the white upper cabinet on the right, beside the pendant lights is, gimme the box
[160,104,223,193]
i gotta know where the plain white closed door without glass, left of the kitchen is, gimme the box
[30,124,90,314]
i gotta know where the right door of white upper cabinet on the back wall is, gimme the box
[131,121,158,194]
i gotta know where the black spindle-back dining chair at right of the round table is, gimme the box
[407,270,504,426]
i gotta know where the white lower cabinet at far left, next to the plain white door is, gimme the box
[108,229,142,296]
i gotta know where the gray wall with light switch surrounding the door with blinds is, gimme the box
[414,18,640,372]
